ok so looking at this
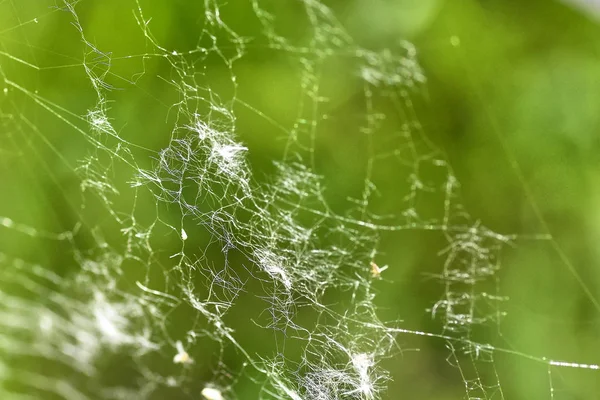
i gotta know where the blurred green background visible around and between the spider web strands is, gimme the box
[0,0,600,399]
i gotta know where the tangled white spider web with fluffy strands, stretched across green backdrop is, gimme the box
[0,0,598,400]
